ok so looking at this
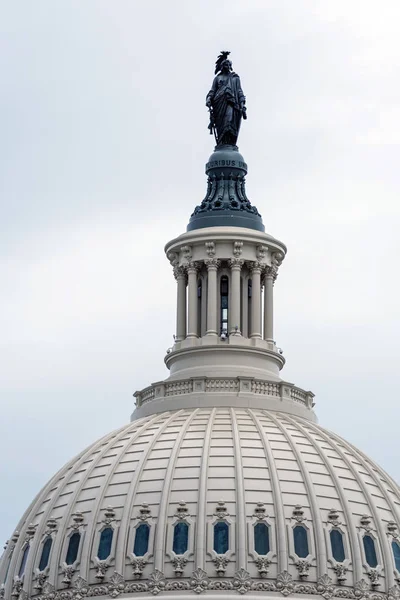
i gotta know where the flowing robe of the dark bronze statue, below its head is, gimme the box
[207,73,245,145]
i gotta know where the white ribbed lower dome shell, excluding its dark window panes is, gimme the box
[0,407,400,600]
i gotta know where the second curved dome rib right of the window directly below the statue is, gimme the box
[247,409,289,573]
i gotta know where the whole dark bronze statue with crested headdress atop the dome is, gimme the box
[206,51,247,146]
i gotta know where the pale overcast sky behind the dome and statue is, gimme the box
[0,0,400,541]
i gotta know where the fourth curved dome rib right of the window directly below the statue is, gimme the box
[286,417,364,582]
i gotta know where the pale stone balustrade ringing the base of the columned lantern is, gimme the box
[134,377,314,410]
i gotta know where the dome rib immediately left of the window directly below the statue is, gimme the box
[195,408,217,569]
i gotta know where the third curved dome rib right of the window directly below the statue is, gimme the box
[268,413,328,578]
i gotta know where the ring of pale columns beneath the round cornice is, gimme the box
[174,258,276,342]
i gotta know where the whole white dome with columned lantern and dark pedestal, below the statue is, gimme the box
[0,54,400,600]
